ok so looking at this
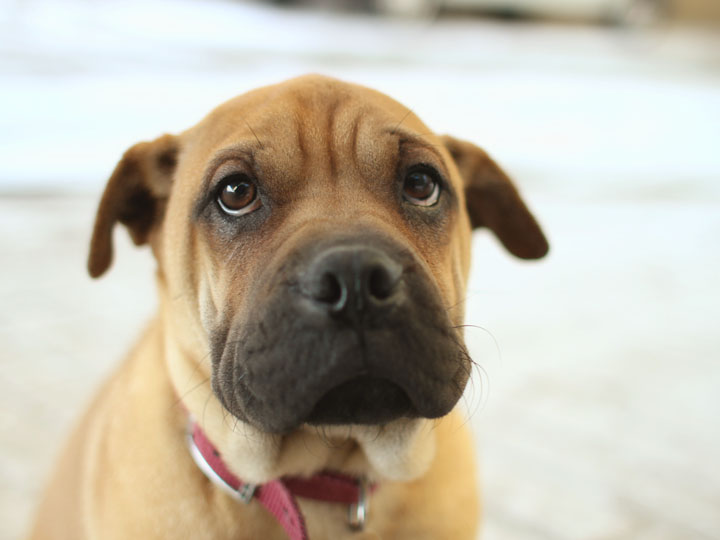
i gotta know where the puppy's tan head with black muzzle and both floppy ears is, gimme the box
[89,76,548,476]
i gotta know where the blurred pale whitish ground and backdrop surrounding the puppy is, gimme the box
[0,0,720,540]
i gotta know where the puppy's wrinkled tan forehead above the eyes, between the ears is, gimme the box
[180,78,446,192]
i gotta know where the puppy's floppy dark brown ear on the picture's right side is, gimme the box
[441,135,549,259]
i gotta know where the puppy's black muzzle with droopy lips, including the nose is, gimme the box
[213,234,469,433]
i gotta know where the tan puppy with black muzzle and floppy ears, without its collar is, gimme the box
[32,76,548,540]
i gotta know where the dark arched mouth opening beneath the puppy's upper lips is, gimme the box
[307,375,419,425]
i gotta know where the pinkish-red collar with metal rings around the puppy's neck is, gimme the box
[187,420,375,540]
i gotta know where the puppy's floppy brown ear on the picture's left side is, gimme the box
[88,135,178,277]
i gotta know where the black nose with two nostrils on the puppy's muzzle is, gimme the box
[304,246,403,321]
